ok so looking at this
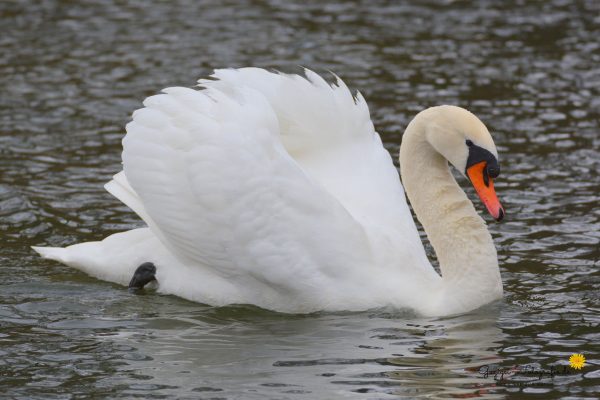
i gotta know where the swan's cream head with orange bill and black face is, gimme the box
[426,106,504,221]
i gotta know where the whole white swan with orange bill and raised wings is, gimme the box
[34,68,504,315]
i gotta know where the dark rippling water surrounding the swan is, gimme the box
[0,0,600,399]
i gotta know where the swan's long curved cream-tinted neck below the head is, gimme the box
[400,116,502,313]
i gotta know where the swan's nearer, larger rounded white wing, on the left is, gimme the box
[123,75,371,290]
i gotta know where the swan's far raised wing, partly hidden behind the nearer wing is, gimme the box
[200,68,429,239]
